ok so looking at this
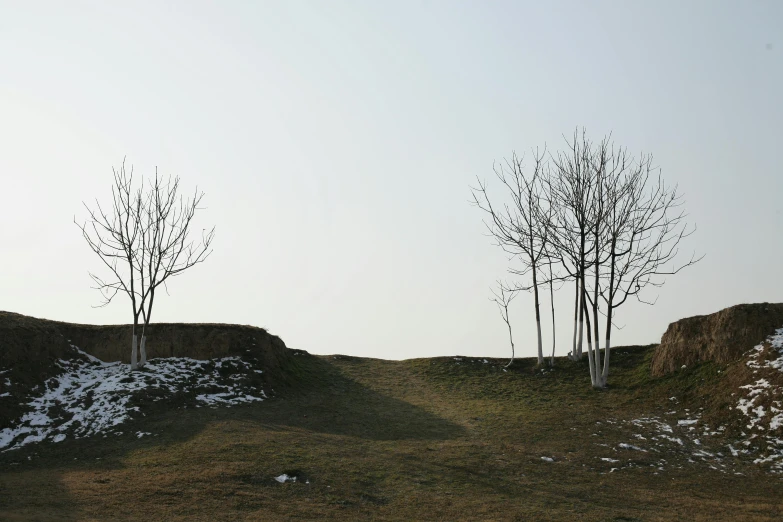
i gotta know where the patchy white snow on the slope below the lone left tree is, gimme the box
[0,347,266,451]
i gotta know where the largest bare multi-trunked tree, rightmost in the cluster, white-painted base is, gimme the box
[547,130,700,388]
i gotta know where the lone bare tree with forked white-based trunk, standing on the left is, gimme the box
[74,159,215,370]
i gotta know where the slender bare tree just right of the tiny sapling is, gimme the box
[471,151,548,365]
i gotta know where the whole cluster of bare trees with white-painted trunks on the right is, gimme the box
[472,130,701,388]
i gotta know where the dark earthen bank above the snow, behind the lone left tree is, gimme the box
[0,311,307,425]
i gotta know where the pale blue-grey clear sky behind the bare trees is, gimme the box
[0,0,783,359]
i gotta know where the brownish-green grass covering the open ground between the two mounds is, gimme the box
[0,347,783,520]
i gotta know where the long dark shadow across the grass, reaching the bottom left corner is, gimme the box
[0,354,464,520]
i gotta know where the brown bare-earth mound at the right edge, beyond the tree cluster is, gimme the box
[651,303,783,377]
